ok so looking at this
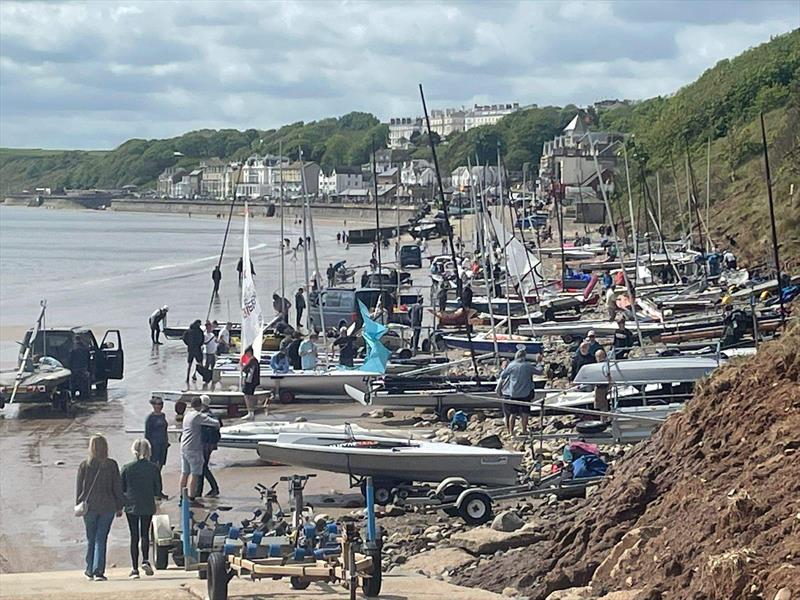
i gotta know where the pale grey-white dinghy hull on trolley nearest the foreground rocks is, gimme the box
[258,433,522,485]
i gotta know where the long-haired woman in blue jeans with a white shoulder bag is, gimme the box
[75,434,125,581]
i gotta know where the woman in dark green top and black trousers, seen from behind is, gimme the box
[120,439,161,579]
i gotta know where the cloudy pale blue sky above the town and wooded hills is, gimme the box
[0,0,800,149]
